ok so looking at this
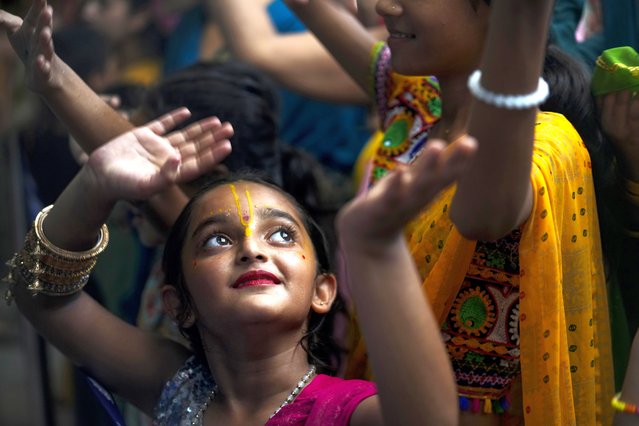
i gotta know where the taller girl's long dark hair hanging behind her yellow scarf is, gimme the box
[541,44,620,262]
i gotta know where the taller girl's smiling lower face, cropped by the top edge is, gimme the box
[376,0,488,78]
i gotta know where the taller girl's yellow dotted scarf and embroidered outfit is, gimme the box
[348,41,613,426]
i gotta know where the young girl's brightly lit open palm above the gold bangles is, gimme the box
[86,108,233,204]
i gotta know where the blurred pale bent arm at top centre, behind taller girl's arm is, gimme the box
[207,0,379,104]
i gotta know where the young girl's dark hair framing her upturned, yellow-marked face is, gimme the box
[162,173,345,373]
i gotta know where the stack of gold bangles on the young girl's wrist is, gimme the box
[3,206,109,304]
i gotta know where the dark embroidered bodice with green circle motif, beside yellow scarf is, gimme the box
[442,230,521,406]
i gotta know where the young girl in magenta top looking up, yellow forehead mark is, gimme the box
[2,104,474,425]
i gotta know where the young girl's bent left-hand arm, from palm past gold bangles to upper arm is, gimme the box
[11,109,232,413]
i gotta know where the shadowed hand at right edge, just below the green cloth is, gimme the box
[597,91,639,182]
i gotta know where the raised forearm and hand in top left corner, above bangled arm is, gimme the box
[0,0,133,153]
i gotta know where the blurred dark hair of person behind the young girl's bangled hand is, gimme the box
[143,61,282,184]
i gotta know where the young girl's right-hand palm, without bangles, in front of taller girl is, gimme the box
[337,137,477,251]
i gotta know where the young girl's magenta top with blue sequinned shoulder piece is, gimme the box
[154,357,377,426]
